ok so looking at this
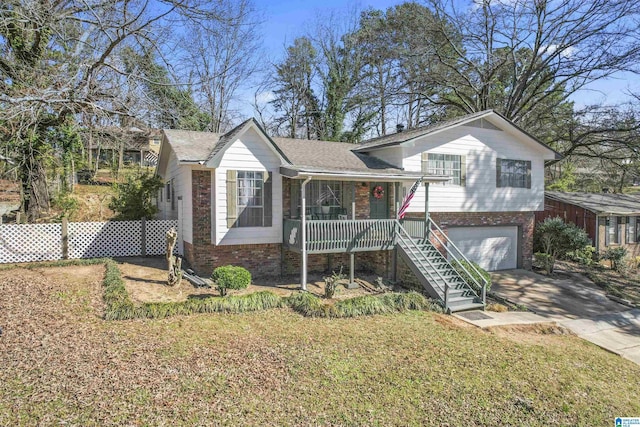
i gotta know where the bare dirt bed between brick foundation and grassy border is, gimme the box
[118,257,388,304]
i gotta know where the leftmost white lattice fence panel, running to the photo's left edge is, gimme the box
[0,224,62,263]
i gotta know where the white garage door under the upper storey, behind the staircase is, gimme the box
[448,226,518,271]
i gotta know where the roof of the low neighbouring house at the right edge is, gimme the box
[545,191,640,215]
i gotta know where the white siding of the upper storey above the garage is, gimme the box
[400,126,548,212]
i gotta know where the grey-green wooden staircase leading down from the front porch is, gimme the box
[396,223,485,313]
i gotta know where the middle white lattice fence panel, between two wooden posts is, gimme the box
[69,221,142,258]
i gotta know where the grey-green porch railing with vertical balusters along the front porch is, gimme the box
[283,219,396,254]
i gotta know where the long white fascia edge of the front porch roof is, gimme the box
[280,166,451,182]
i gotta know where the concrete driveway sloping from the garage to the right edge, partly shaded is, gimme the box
[491,270,640,364]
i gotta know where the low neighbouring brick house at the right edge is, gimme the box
[536,191,640,256]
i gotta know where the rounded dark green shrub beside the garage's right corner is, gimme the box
[533,217,591,274]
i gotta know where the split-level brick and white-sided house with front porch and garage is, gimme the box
[157,111,558,307]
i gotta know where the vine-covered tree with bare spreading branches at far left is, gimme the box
[0,0,260,220]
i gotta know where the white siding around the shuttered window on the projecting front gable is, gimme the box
[212,128,282,245]
